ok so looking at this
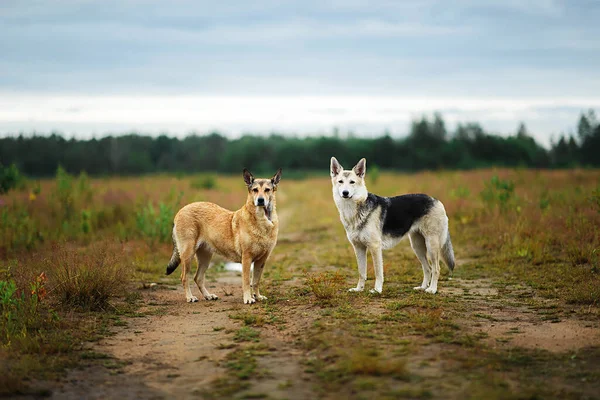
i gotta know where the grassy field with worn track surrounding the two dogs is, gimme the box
[0,169,600,399]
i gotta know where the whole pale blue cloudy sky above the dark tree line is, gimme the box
[0,0,600,145]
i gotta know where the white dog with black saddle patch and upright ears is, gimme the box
[331,157,454,293]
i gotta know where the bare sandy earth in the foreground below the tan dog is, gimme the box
[53,273,313,399]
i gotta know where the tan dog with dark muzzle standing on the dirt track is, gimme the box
[167,168,281,304]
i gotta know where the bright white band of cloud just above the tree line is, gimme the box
[0,94,600,145]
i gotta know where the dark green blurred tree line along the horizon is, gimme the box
[0,110,600,177]
